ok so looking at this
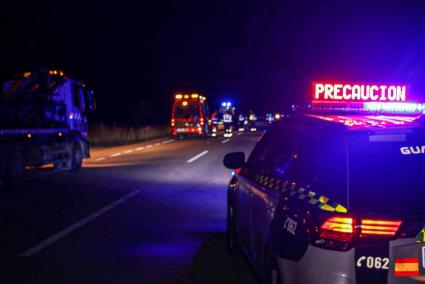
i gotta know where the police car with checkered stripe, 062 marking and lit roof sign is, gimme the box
[224,84,425,284]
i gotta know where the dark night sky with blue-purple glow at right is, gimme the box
[0,0,425,124]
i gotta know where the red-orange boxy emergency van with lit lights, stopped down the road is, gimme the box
[171,93,210,138]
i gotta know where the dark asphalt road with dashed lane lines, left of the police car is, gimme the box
[0,136,256,284]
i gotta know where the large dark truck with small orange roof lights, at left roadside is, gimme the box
[0,69,95,188]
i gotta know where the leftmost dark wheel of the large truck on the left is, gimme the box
[4,151,25,190]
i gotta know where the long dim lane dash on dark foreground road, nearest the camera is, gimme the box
[19,190,141,257]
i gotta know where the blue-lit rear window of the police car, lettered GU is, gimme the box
[348,131,425,215]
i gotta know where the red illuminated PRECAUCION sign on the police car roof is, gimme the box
[314,83,406,102]
